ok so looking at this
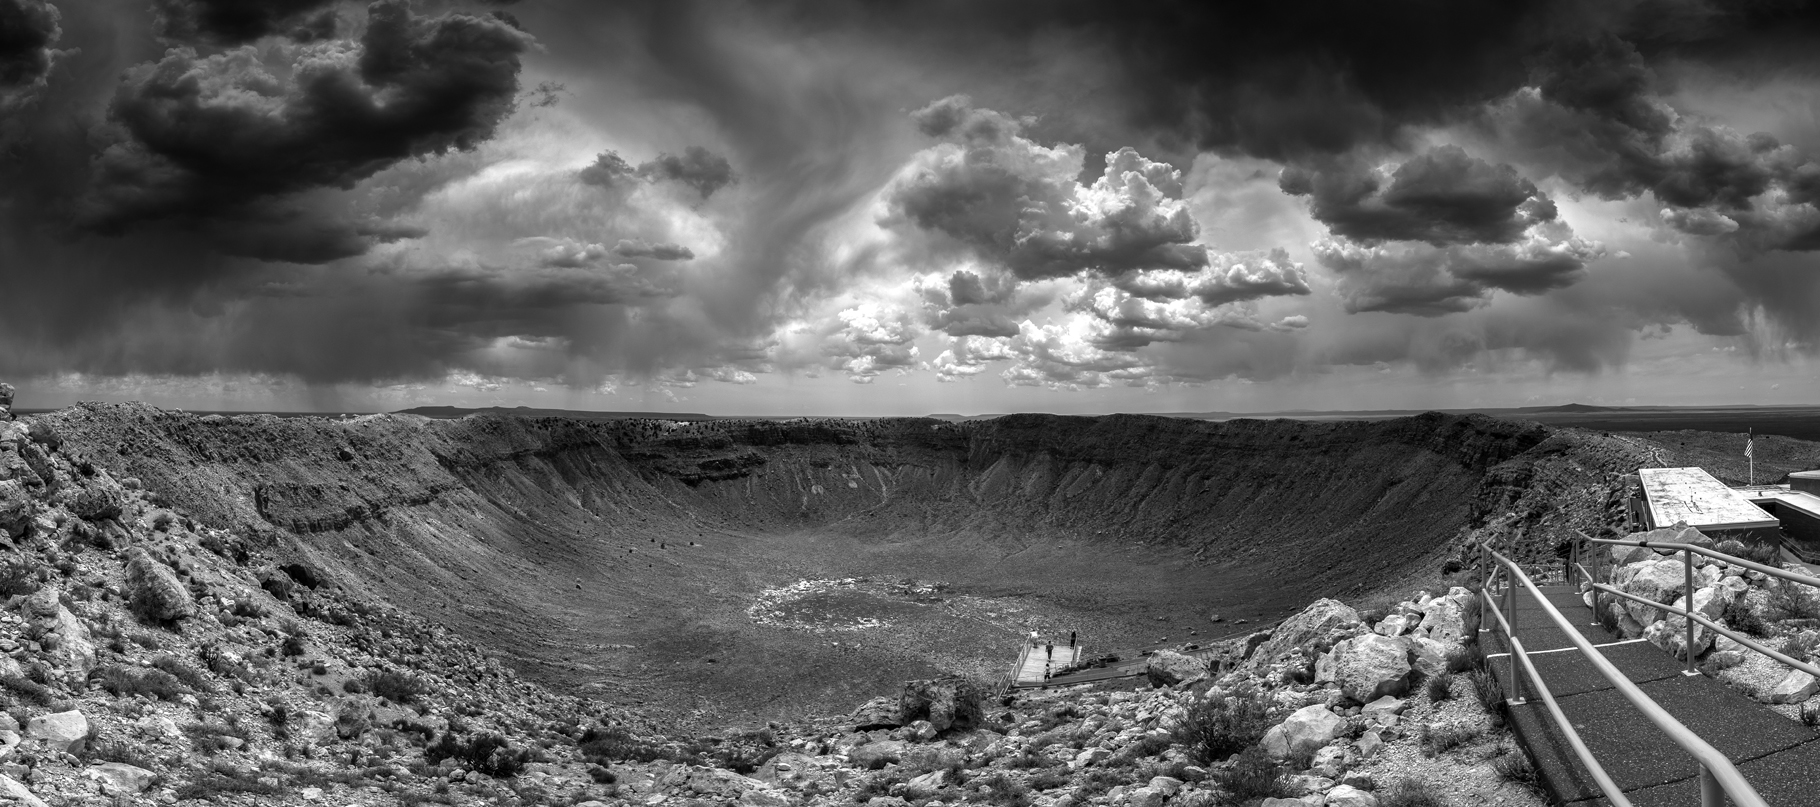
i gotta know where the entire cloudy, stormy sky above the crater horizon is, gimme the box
[0,0,1820,415]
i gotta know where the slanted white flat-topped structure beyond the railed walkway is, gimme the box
[1631,468,1776,543]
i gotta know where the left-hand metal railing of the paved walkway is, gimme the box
[1480,543,1769,807]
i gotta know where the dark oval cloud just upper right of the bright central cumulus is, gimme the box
[1281,146,1556,246]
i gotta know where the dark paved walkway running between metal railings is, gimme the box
[1480,587,1820,807]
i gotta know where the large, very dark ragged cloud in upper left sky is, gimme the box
[84,0,528,260]
